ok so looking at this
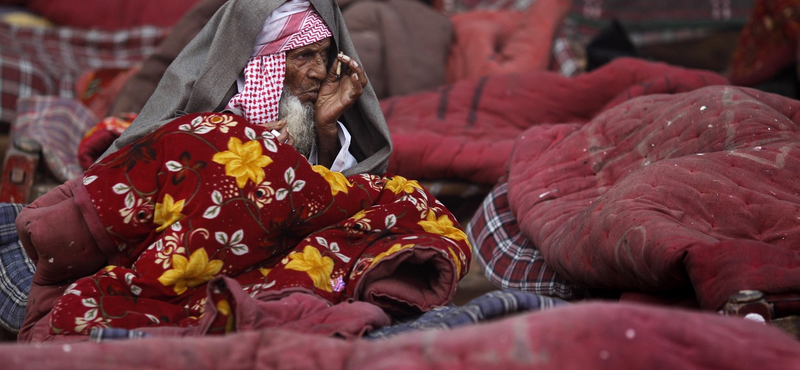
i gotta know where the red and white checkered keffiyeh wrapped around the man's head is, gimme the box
[228,0,331,124]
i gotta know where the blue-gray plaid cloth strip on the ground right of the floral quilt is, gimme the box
[366,290,569,339]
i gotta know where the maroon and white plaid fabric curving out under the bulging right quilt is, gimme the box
[465,178,585,300]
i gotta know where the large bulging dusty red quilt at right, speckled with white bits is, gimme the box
[509,86,800,310]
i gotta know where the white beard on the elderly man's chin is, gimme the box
[278,92,316,158]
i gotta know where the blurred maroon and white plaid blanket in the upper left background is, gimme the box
[0,23,167,123]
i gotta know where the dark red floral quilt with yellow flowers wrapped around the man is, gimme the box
[31,113,471,342]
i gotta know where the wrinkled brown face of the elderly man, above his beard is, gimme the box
[284,37,331,103]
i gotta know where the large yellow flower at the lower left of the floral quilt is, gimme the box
[158,249,222,295]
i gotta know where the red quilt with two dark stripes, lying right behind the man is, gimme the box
[381,58,727,184]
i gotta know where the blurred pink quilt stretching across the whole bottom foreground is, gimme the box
[0,303,800,370]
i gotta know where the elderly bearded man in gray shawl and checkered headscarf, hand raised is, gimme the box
[104,0,391,175]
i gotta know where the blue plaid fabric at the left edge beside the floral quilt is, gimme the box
[0,203,35,333]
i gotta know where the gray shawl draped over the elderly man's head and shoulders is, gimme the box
[103,0,392,175]
